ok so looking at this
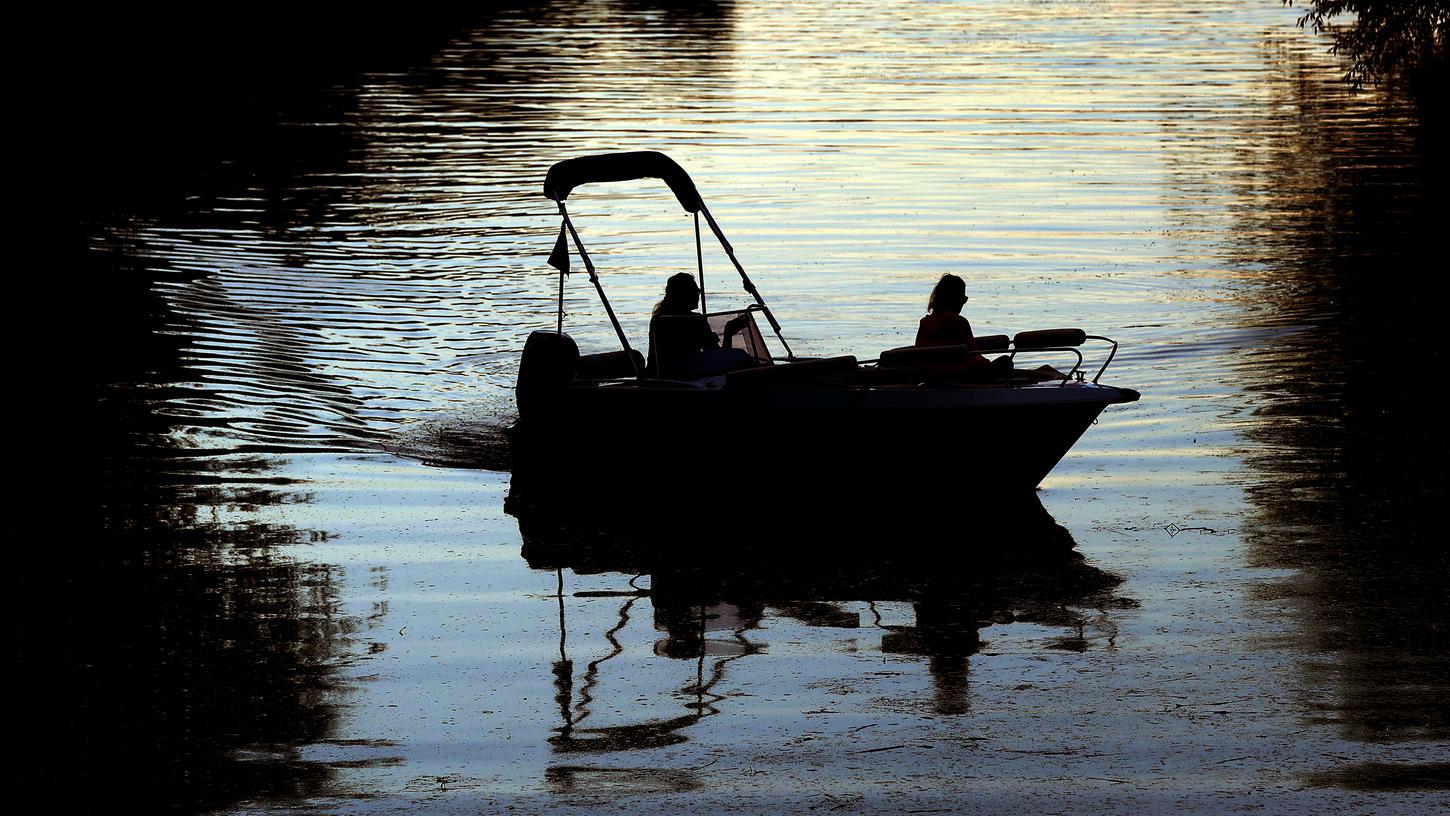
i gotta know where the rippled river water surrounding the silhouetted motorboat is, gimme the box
[39,0,1450,813]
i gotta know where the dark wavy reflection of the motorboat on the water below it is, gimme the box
[508,491,1135,790]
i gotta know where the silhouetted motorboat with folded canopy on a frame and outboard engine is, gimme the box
[510,152,1138,512]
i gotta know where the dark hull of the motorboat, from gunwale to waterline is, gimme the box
[512,383,1137,507]
